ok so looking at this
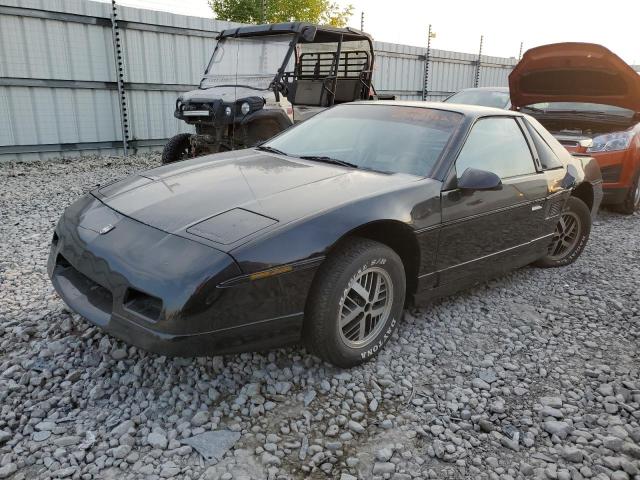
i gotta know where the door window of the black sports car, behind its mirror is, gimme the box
[456,117,536,178]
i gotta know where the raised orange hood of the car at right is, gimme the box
[509,43,640,112]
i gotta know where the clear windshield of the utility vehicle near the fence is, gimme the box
[200,34,294,90]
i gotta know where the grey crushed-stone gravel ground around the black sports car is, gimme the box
[0,155,640,480]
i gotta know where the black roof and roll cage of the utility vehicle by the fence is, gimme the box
[218,22,374,107]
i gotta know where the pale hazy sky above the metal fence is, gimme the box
[107,0,640,65]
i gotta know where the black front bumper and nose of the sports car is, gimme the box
[47,195,311,356]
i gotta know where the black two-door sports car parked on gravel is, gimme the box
[48,102,602,366]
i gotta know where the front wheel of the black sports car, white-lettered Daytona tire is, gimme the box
[303,238,406,367]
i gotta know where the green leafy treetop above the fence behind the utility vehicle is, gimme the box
[209,0,353,27]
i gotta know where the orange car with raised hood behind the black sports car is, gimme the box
[509,43,640,214]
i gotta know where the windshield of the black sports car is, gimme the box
[262,104,463,177]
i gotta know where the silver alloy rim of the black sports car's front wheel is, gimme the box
[338,267,393,348]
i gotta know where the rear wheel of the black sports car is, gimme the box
[536,197,591,268]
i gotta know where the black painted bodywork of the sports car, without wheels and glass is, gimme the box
[48,102,602,356]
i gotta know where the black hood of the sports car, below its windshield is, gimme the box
[92,149,418,250]
